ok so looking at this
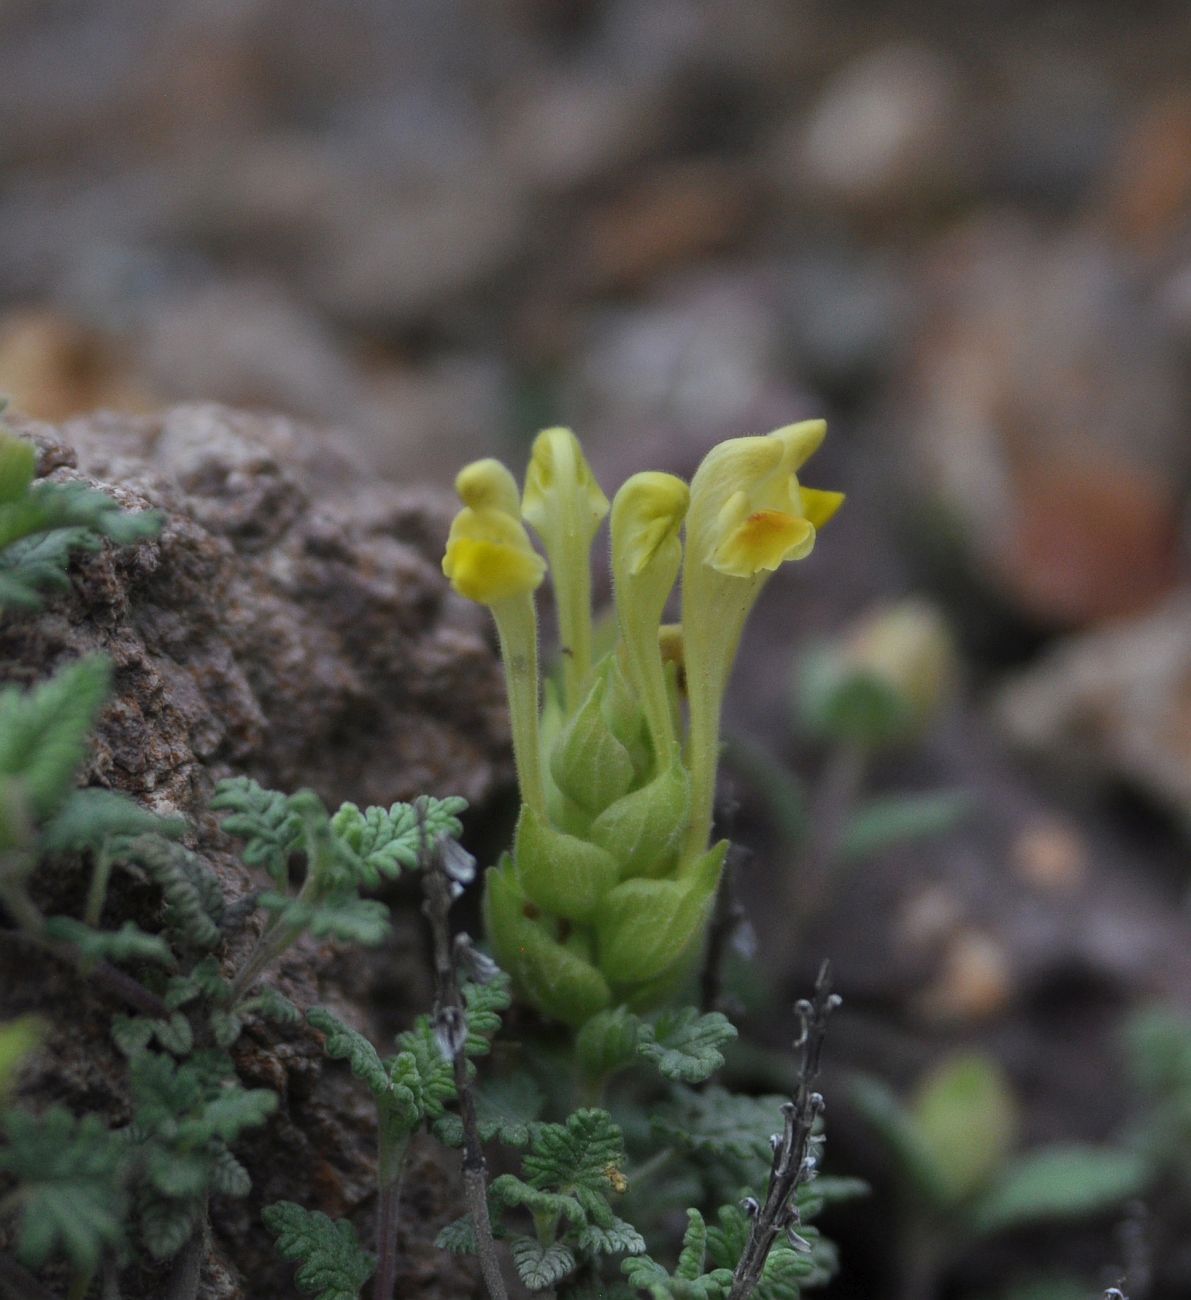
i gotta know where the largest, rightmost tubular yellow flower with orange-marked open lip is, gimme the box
[683,420,844,854]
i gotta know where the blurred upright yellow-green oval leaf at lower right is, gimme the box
[910,1052,1017,1203]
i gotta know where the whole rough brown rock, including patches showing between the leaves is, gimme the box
[0,406,510,1300]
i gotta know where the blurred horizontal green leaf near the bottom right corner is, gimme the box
[969,1144,1149,1236]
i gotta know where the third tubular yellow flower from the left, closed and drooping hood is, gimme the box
[612,472,690,767]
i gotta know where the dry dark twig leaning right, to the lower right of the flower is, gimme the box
[728,961,840,1300]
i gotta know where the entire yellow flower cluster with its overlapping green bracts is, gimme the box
[443,421,843,1026]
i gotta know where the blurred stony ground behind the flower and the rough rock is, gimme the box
[0,0,1191,1300]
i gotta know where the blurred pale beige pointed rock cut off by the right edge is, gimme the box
[996,592,1191,815]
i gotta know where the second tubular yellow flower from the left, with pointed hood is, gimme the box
[521,429,609,711]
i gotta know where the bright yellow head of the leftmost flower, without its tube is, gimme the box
[442,460,546,605]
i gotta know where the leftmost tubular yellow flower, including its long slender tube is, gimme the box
[442,459,546,813]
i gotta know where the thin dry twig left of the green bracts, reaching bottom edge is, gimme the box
[415,801,508,1300]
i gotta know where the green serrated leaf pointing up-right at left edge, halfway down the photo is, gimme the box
[0,655,111,835]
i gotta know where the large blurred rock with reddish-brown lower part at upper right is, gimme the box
[889,213,1188,627]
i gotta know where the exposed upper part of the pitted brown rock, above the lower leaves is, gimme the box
[0,406,510,813]
